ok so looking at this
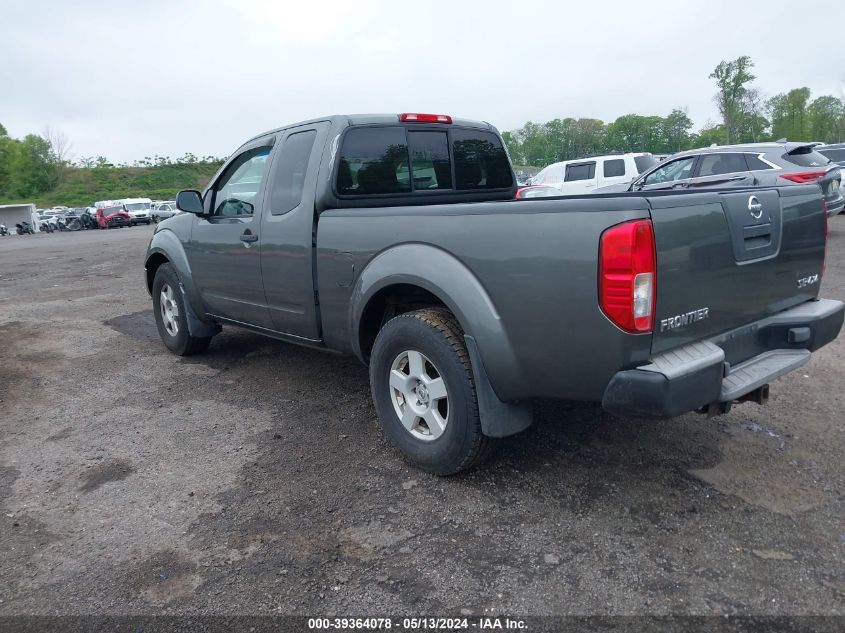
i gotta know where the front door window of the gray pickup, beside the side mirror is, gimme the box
[211,147,270,218]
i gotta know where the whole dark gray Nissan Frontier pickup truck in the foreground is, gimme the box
[145,114,845,475]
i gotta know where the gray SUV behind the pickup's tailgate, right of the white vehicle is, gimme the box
[596,141,845,215]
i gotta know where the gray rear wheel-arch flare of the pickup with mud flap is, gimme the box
[349,243,530,436]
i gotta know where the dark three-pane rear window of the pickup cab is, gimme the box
[335,125,513,196]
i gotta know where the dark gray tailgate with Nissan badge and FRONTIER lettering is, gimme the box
[649,185,826,354]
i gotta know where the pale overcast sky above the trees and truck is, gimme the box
[0,0,845,162]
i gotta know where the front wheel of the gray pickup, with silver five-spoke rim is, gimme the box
[153,264,211,356]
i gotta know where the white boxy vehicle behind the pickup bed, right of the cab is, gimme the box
[531,152,657,196]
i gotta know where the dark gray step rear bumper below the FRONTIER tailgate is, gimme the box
[602,299,845,418]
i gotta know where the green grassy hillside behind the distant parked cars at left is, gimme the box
[0,162,220,208]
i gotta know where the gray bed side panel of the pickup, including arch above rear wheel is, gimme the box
[317,197,651,400]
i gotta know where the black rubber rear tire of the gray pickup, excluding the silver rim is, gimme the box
[370,308,495,475]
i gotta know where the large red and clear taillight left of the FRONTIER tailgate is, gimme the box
[599,220,657,334]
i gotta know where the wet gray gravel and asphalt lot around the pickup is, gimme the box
[0,216,845,616]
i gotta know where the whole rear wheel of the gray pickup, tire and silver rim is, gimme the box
[370,308,495,475]
